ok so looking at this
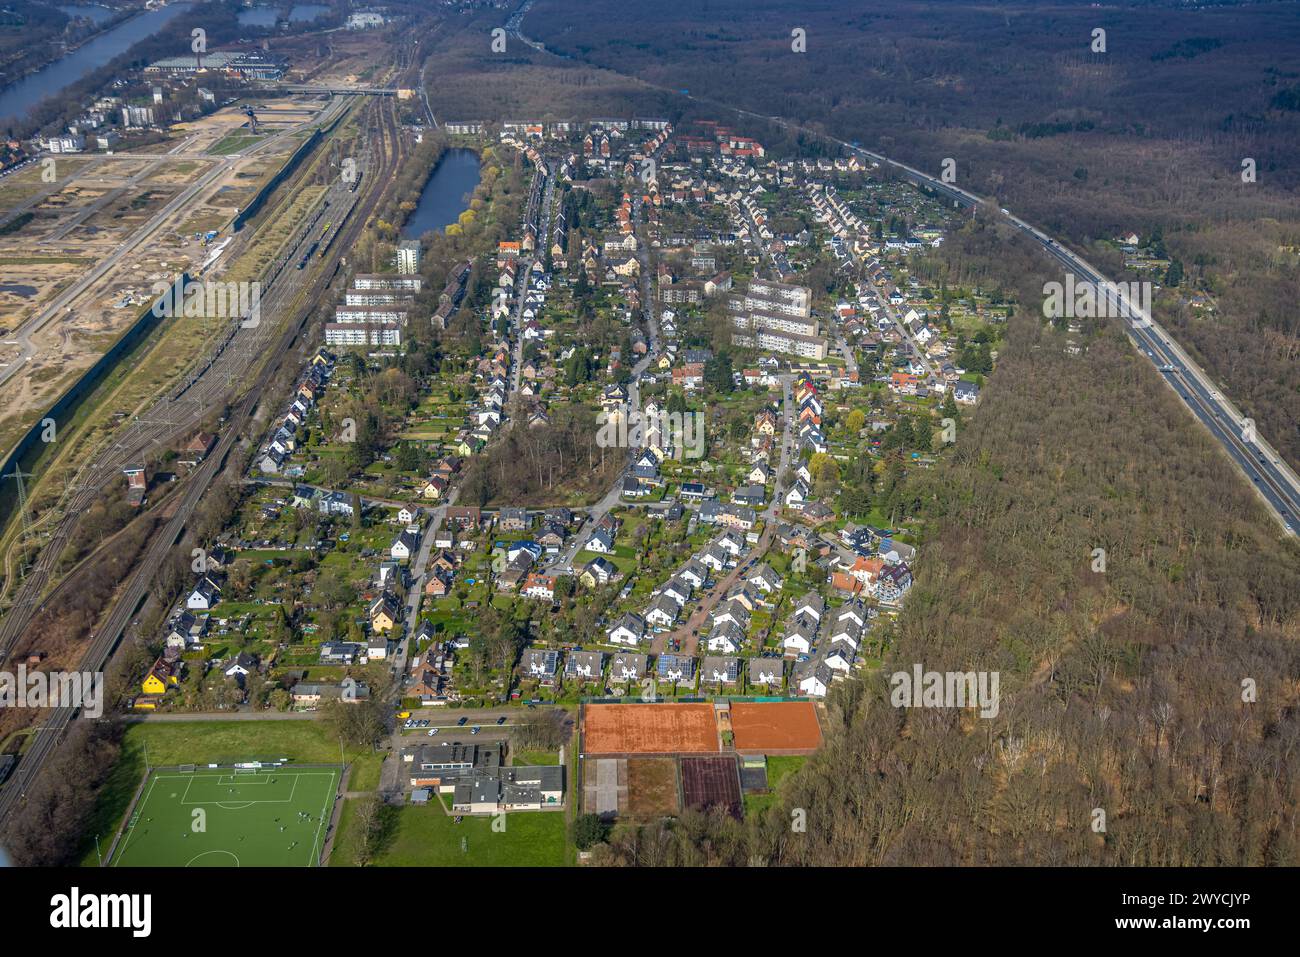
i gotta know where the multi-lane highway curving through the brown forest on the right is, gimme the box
[508,0,1300,536]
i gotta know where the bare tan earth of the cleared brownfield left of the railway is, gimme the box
[0,100,324,450]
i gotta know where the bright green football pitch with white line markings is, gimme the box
[112,767,341,867]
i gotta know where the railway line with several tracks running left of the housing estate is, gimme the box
[0,98,402,822]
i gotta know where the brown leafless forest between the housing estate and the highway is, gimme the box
[598,214,1300,866]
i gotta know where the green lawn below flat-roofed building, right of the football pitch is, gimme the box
[329,801,573,867]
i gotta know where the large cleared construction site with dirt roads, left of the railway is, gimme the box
[0,98,340,460]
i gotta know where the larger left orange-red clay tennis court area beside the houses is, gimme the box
[582,703,719,754]
